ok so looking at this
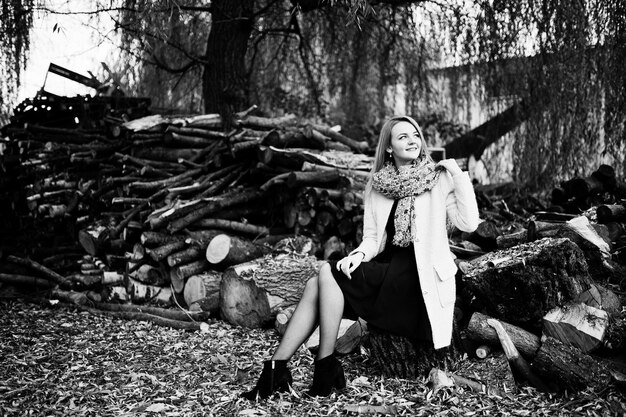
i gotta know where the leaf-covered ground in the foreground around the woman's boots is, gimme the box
[0,300,626,416]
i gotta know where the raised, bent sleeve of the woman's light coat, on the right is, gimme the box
[442,171,480,232]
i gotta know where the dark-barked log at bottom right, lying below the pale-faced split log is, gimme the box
[531,337,611,391]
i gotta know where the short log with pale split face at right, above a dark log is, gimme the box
[543,303,609,352]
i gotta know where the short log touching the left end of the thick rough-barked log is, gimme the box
[183,271,222,315]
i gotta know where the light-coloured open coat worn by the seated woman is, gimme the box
[352,171,479,349]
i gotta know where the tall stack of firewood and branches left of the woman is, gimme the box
[3,105,371,314]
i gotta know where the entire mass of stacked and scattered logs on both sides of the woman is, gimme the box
[0,104,626,390]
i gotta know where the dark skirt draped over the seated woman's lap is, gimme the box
[330,242,432,341]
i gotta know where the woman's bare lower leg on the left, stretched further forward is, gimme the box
[272,277,319,360]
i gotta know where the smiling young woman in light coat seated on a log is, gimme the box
[242,116,479,400]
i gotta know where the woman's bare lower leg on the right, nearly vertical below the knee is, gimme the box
[317,264,344,359]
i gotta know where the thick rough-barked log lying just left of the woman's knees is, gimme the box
[220,253,322,328]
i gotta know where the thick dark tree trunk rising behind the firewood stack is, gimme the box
[202,0,254,122]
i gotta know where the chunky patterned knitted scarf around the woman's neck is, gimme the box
[372,158,445,247]
